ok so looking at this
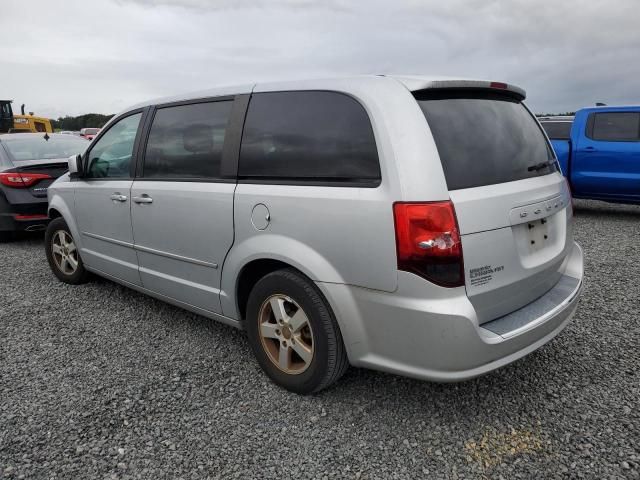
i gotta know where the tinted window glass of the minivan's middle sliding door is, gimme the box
[143,100,233,179]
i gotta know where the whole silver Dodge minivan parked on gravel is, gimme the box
[45,76,583,394]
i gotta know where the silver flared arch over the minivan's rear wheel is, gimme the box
[220,233,345,319]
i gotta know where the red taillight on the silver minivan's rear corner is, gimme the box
[393,201,464,287]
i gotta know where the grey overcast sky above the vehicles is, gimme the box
[0,0,640,118]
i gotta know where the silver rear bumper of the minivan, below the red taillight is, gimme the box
[318,244,583,382]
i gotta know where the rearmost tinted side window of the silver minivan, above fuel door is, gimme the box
[238,91,380,186]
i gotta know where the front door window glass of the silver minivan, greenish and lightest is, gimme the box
[87,113,142,178]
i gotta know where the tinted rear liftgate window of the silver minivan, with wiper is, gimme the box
[415,90,558,190]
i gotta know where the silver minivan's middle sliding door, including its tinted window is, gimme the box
[131,99,235,313]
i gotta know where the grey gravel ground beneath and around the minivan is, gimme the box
[0,202,640,479]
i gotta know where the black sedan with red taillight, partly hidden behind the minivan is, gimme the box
[0,133,89,240]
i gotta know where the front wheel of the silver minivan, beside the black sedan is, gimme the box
[44,217,90,285]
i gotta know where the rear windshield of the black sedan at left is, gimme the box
[2,134,89,161]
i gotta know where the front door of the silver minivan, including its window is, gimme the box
[75,112,142,285]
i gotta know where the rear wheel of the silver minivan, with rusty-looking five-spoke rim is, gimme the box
[246,269,349,395]
